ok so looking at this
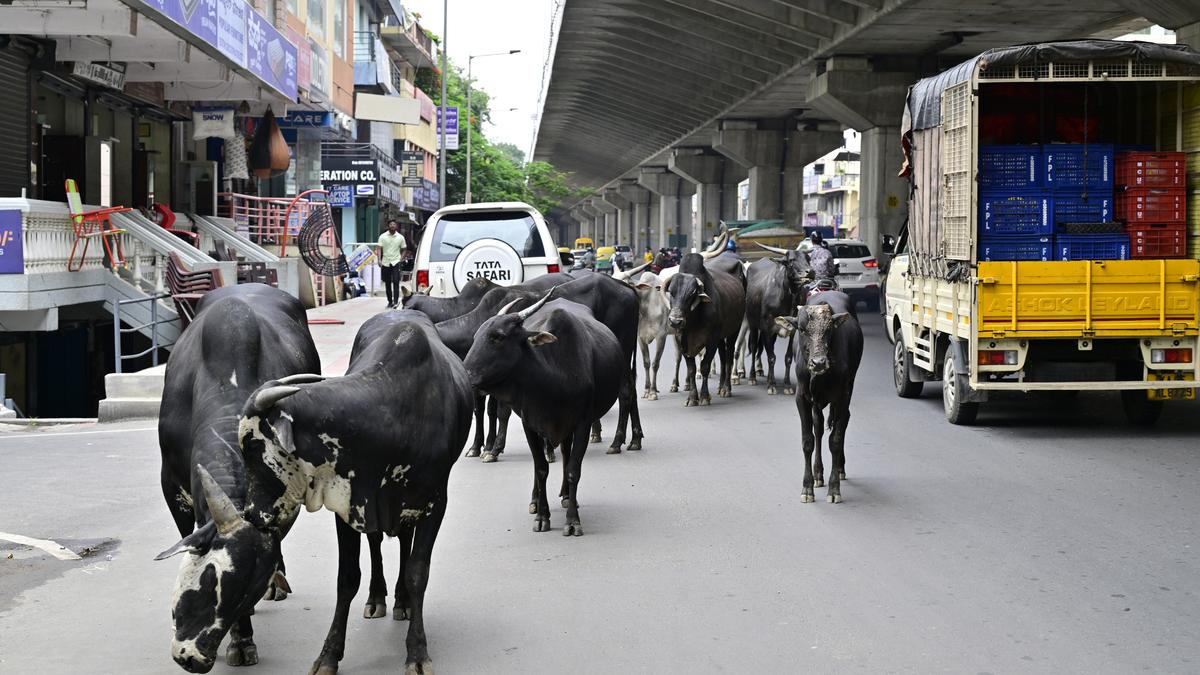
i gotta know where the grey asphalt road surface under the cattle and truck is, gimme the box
[0,321,1200,674]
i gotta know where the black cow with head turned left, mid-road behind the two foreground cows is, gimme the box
[466,293,630,537]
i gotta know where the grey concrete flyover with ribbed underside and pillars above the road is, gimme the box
[534,0,1200,247]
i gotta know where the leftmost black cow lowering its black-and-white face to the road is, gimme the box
[158,283,320,673]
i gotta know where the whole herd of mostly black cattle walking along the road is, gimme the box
[158,228,863,675]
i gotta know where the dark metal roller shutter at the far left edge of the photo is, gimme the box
[0,48,30,197]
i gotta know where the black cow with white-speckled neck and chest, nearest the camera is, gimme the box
[239,310,473,675]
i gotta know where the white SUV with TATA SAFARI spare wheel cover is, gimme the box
[413,202,559,298]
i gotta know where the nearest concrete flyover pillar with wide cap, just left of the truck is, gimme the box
[808,56,917,255]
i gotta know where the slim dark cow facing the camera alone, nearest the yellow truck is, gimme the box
[775,291,863,503]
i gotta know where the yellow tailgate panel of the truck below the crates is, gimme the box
[974,259,1200,340]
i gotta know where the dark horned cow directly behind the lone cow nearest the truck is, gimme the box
[744,244,812,395]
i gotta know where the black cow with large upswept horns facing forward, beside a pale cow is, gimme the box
[665,253,745,406]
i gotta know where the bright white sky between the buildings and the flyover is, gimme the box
[401,0,562,155]
